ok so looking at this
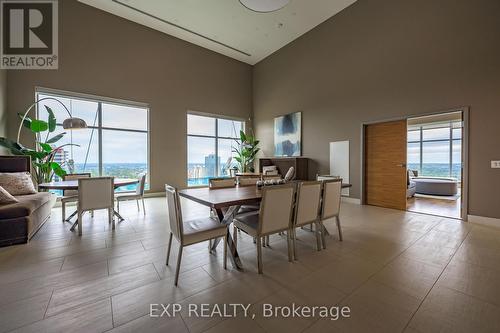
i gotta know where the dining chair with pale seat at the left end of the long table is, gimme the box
[165,184,228,286]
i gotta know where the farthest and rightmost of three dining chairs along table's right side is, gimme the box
[319,178,342,249]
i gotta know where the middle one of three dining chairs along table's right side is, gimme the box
[292,181,322,260]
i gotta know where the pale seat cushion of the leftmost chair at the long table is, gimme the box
[183,217,227,245]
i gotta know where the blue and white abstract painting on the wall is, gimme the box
[274,112,302,156]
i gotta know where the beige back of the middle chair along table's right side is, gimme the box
[295,181,322,227]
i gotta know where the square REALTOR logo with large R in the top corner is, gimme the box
[0,0,58,69]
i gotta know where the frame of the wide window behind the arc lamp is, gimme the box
[35,87,151,193]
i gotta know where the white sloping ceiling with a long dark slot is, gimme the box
[79,0,356,65]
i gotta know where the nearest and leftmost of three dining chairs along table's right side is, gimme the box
[233,184,295,274]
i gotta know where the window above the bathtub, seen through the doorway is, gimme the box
[407,121,462,180]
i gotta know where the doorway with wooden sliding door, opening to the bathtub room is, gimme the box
[361,108,468,220]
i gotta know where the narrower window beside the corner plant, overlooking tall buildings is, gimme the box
[187,114,244,186]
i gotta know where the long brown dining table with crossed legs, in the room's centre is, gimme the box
[179,183,352,270]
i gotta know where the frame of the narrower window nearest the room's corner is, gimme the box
[186,110,246,188]
